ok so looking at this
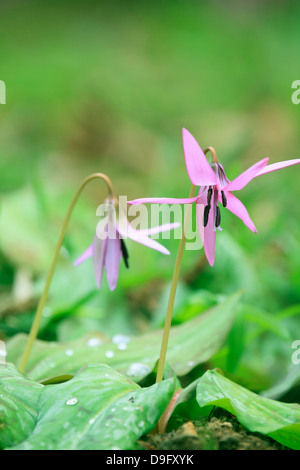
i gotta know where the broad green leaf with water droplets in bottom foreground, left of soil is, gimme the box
[8,364,174,450]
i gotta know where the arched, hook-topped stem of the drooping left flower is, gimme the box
[19,173,115,374]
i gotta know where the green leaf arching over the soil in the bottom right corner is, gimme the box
[197,371,300,450]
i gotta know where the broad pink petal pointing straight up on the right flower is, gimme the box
[182,129,217,186]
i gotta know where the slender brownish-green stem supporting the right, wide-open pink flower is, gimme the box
[156,184,196,382]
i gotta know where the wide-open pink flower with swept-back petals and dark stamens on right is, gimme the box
[129,129,300,266]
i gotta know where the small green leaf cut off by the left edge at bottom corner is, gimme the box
[0,364,43,449]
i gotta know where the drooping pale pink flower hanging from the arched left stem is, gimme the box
[74,201,180,290]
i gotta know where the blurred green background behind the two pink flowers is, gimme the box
[0,0,300,396]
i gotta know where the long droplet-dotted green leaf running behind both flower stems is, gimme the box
[7,293,241,381]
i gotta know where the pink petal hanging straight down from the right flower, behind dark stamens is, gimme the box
[196,191,217,266]
